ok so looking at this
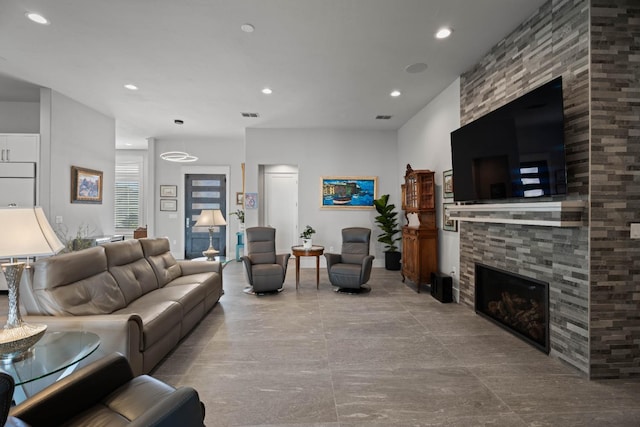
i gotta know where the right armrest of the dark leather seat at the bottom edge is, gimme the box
[129,387,204,427]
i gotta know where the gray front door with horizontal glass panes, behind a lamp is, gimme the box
[184,174,228,259]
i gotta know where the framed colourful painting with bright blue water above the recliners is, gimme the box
[320,176,378,209]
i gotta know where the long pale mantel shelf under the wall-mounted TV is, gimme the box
[446,200,587,227]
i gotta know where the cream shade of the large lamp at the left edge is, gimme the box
[0,206,64,258]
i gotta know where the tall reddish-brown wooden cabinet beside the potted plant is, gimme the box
[402,165,438,292]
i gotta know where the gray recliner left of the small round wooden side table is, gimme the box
[242,227,291,294]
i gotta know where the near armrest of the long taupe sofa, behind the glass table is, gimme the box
[23,314,144,375]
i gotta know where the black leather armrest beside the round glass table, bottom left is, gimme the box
[10,353,133,426]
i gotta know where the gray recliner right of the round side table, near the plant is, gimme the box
[324,227,374,293]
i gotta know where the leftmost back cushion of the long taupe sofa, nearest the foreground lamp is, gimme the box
[32,246,126,316]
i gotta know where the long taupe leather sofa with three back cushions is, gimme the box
[20,238,222,375]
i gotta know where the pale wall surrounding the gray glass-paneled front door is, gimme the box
[152,138,244,259]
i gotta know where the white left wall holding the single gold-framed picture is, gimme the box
[40,89,115,242]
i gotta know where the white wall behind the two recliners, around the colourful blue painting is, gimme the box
[245,129,400,267]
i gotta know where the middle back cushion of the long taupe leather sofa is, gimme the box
[103,240,158,304]
